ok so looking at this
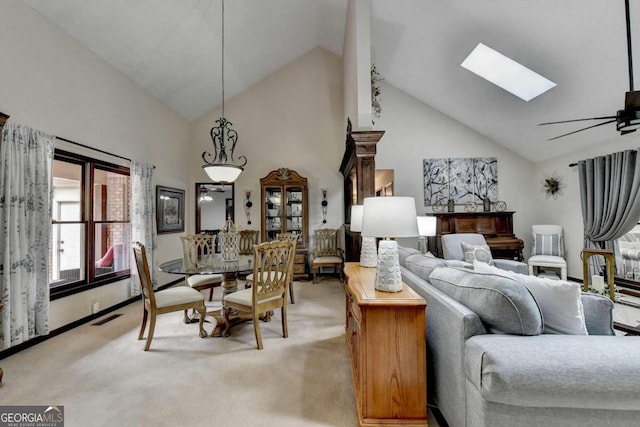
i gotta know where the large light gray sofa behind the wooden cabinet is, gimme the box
[400,247,640,427]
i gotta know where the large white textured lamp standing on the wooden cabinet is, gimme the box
[362,196,418,292]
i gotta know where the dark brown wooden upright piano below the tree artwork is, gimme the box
[433,212,524,261]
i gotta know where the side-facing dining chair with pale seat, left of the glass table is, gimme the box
[131,242,207,351]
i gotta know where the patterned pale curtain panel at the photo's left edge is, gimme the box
[0,123,54,348]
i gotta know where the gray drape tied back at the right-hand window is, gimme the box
[578,150,640,273]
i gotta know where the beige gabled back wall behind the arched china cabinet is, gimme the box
[190,48,345,239]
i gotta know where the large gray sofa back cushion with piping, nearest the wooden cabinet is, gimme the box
[429,267,543,335]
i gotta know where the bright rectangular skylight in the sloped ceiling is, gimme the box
[460,43,556,101]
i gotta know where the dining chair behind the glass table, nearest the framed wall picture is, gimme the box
[180,234,224,301]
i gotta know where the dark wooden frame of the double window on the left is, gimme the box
[49,148,131,301]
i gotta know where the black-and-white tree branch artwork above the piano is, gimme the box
[423,157,498,206]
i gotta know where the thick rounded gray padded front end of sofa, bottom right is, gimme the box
[464,335,640,410]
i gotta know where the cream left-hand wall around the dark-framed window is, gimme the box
[0,0,193,329]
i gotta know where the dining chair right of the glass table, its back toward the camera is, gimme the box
[222,241,295,350]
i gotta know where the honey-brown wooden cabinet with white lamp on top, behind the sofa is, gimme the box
[344,262,427,427]
